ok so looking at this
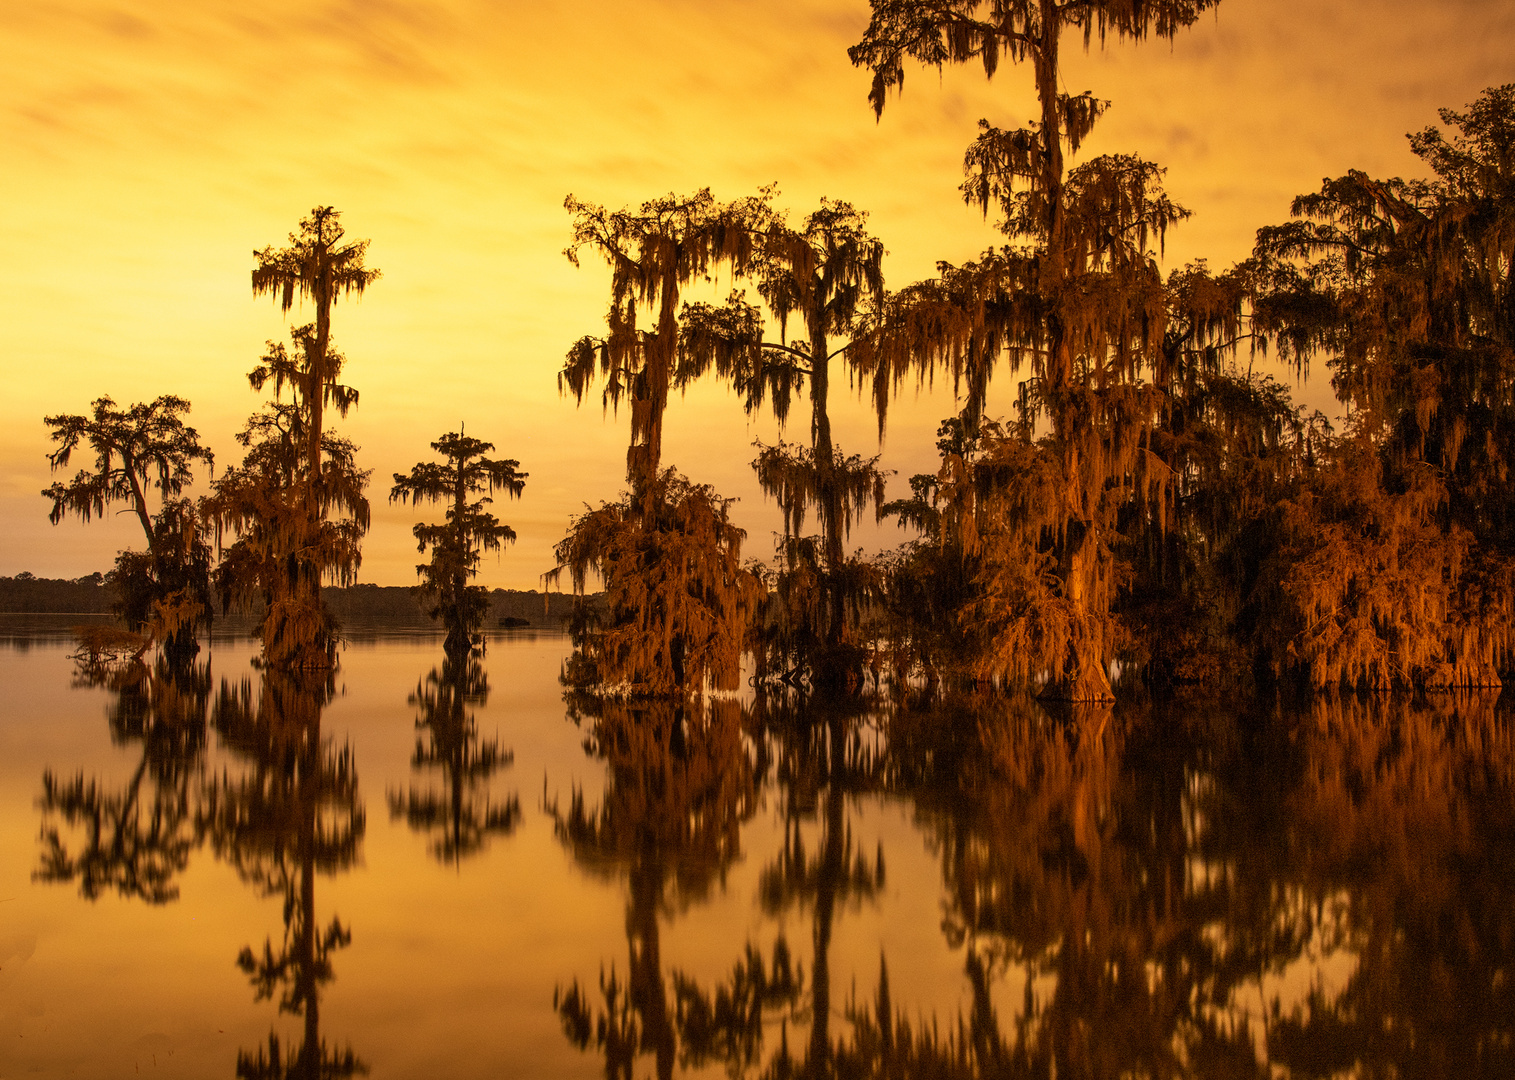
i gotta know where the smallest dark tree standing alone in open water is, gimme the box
[389,432,527,653]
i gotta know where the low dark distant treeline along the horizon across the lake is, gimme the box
[0,573,574,627]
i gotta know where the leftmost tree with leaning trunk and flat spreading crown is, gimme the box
[42,395,214,656]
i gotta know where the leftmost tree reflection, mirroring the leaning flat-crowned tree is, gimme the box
[33,657,211,904]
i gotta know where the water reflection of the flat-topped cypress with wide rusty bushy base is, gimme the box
[547,697,797,1077]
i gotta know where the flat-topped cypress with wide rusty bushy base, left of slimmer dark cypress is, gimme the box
[550,191,762,695]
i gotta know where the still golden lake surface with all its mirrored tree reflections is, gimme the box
[0,616,1515,1080]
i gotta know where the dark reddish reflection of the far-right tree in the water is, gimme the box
[1270,694,1515,1077]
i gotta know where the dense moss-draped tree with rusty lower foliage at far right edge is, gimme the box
[1257,85,1515,688]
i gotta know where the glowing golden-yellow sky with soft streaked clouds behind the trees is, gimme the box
[0,0,1515,588]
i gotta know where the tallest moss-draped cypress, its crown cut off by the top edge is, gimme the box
[850,0,1214,700]
